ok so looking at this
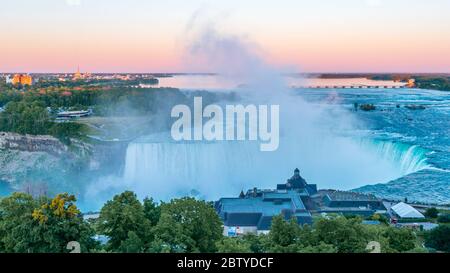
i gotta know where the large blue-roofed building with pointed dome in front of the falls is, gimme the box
[215,169,386,236]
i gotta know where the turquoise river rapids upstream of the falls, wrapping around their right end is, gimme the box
[296,86,450,203]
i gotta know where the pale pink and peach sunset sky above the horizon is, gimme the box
[0,0,450,73]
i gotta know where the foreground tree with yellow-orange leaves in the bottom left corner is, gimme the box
[0,193,96,253]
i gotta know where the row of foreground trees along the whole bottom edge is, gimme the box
[0,189,450,253]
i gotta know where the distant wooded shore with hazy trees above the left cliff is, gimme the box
[0,82,236,138]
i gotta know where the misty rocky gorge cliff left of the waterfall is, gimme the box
[0,132,127,191]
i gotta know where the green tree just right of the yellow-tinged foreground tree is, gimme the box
[98,191,151,251]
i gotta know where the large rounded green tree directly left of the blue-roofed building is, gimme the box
[155,198,222,253]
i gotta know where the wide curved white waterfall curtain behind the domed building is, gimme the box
[123,136,428,199]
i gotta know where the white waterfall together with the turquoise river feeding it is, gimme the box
[117,75,450,203]
